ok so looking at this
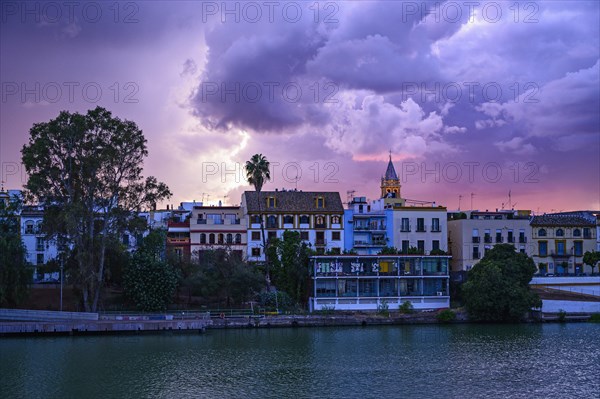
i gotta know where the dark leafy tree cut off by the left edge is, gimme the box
[0,200,32,307]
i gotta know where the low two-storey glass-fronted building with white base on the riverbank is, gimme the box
[309,255,450,311]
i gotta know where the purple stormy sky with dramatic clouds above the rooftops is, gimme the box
[0,0,600,213]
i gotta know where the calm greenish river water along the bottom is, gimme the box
[0,323,600,399]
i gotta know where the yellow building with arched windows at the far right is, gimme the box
[531,212,597,275]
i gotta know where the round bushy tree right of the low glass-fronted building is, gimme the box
[462,244,541,321]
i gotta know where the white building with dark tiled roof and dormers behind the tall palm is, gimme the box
[241,190,344,262]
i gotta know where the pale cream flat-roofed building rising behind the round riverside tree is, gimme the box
[448,211,535,272]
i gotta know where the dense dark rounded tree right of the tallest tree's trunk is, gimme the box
[123,230,179,311]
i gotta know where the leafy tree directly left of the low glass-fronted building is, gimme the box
[272,230,313,303]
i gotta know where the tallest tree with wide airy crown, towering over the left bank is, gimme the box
[21,107,171,311]
